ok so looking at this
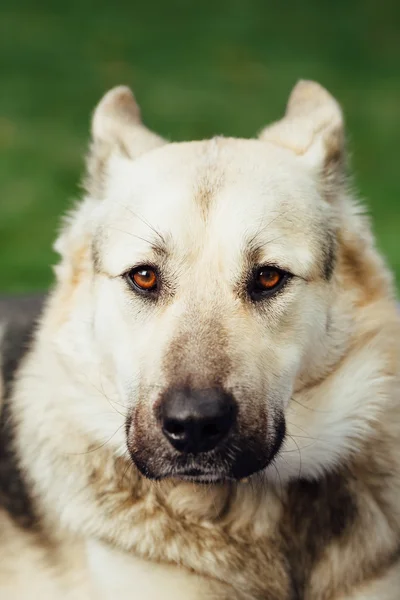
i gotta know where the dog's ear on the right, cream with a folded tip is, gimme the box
[259,81,346,190]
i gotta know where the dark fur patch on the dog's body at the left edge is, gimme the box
[0,295,44,528]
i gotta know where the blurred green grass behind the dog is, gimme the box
[0,0,400,292]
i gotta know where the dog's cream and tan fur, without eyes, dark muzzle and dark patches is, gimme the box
[0,82,400,600]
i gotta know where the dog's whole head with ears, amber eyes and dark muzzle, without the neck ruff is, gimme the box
[52,82,390,482]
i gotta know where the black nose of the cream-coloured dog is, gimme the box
[160,389,236,454]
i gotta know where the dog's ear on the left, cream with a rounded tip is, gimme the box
[84,86,166,199]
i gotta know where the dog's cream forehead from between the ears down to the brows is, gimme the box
[99,138,328,276]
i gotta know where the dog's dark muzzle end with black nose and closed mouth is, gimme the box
[127,388,285,483]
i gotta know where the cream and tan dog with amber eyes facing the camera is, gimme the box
[0,81,400,600]
